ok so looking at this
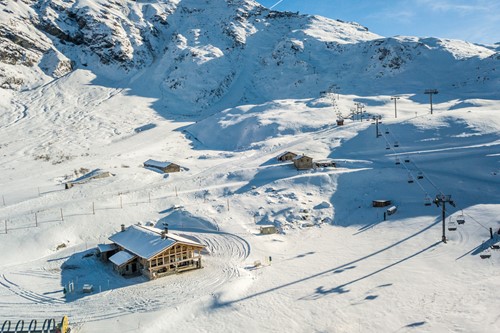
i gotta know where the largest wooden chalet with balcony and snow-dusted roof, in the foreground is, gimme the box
[99,225,205,279]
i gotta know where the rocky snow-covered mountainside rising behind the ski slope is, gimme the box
[0,0,500,114]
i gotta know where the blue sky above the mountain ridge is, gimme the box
[256,0,500,44]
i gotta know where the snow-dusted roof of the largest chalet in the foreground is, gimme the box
[109,225,204,260]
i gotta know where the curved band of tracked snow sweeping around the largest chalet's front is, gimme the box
[0,230,250,326]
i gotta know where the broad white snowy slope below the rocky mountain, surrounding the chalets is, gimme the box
[0,70,500,332]
